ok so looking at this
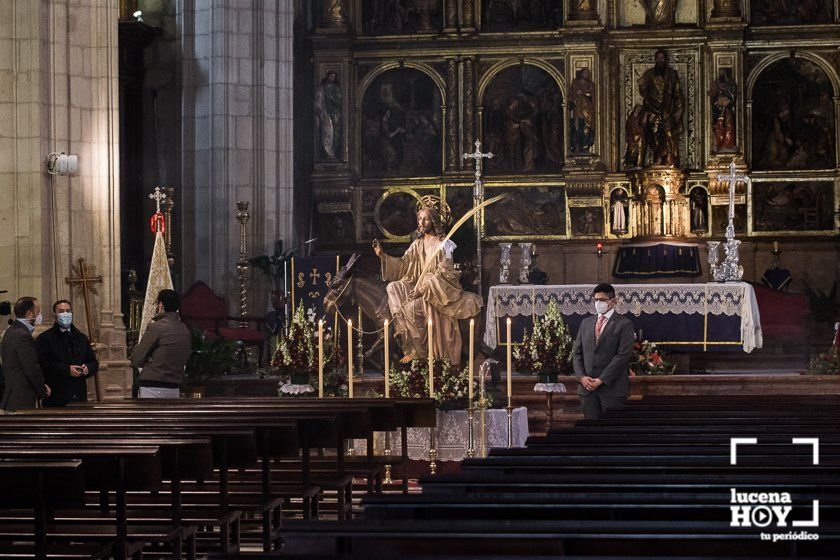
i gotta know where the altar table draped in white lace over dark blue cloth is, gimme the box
[484,282,762,352]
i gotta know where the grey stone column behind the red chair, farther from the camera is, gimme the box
[177,0,294,311]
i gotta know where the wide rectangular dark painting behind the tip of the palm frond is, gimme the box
[483,183,569,241]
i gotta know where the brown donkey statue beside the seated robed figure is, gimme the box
[324,253,394,362]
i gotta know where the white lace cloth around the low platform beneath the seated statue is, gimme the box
[353,406,528,461]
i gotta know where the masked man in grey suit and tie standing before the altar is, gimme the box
[572,284,635,419]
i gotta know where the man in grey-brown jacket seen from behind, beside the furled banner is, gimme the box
[131,290,192,399]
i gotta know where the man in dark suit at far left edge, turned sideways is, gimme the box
[0,296,50,412]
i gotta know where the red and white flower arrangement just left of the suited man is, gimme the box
[513,299,574,382]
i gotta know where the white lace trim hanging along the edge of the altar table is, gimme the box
[484,282,762,352]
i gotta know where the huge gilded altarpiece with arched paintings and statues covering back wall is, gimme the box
[310,0,840,254]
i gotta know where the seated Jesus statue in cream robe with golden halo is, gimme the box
[373,205,482,365]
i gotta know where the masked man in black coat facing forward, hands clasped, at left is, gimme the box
[35,299,99,406]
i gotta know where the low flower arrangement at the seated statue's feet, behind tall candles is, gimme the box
[390,358,490,410]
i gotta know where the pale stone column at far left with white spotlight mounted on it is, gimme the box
[0,0,131,397]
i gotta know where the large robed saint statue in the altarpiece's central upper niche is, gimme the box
[639,49,685,167]
